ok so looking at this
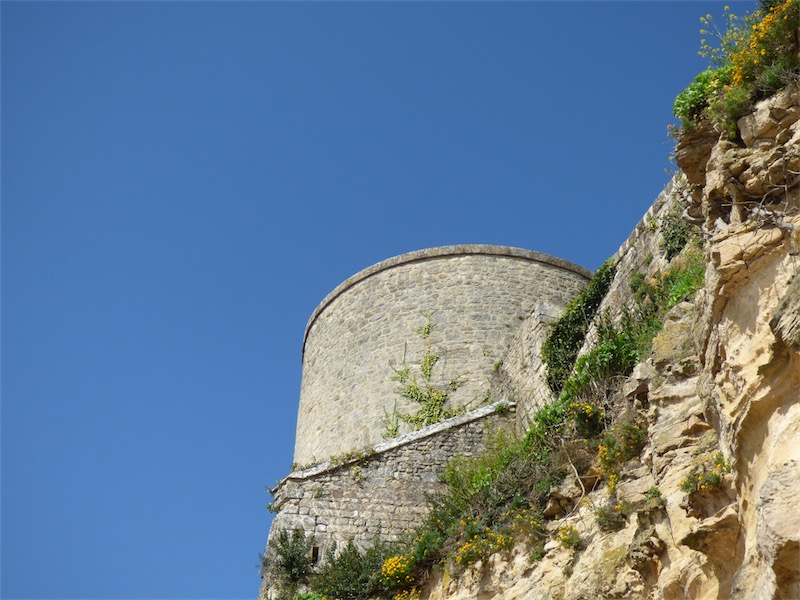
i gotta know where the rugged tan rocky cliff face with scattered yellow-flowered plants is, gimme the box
[423,87,800,600]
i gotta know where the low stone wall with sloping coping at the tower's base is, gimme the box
[268,403,514,580]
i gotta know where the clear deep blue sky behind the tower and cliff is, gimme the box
[0,2,755,599]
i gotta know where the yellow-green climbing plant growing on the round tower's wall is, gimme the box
[384,313,465,437]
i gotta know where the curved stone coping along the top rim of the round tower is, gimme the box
[303,244,592,353]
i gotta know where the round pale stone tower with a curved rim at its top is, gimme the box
[294,245,591,465]
